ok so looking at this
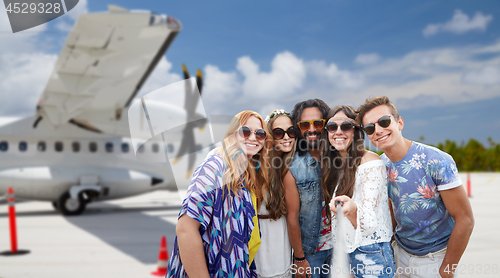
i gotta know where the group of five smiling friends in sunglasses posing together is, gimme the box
[166,97,474,278]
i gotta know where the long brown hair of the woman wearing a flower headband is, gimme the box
[266,114,297,220]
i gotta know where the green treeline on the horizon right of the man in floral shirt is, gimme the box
[377,136,500,172]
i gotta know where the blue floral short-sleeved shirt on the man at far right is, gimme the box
[381,142,462,256]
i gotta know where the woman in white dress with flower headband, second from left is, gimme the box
[255,109,298,278]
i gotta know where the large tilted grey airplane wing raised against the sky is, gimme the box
[34,6,182,134]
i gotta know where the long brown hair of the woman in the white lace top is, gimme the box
[321,105,366,223]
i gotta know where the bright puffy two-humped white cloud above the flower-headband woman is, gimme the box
[236,51,306,99]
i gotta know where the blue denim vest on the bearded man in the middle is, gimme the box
[290,152,323,255]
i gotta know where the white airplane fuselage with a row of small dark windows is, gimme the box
[0,117,176,201]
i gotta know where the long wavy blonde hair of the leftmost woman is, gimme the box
[215,110,272,208]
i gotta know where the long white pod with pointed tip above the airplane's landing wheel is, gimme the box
[0,166,165,202]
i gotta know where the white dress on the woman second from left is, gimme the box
[254,202,292,278]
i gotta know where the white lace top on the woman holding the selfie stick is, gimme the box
[332,160,392,253]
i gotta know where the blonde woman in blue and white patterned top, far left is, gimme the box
[166,111,272,278]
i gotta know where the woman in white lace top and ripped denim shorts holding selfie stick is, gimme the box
[321,105,396,278]
